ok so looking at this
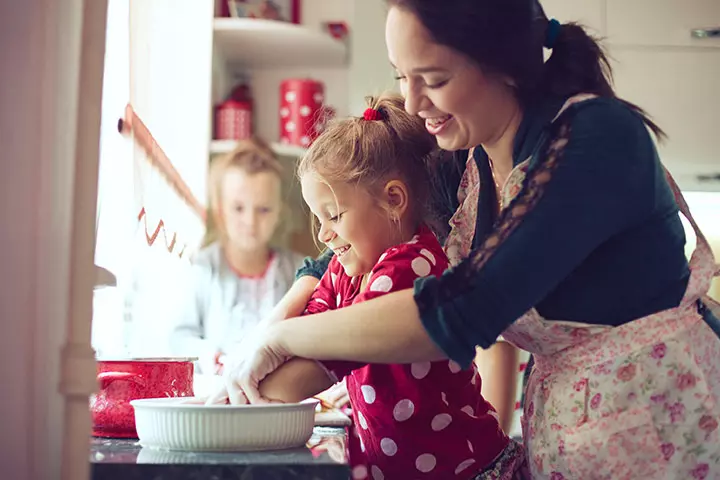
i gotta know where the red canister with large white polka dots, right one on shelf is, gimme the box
[280,78,325,147]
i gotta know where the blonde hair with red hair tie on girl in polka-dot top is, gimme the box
[297,92,438,229]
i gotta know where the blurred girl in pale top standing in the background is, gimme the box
[170,139,302,374]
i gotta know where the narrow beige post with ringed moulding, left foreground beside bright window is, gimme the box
[60,0,107,480]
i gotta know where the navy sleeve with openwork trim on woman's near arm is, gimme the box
[415,99,659,366]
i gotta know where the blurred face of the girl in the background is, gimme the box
[219,167,282,252]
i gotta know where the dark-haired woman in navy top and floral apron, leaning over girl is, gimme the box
[219,0,720,479]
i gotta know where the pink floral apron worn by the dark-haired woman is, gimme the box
[449,96,720,480]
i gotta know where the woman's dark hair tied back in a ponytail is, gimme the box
[387,0,665,138]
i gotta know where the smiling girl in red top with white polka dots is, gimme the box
[248,95,523,480]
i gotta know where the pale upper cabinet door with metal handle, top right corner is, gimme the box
[607,0,720,47]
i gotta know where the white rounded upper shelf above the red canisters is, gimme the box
[213,18,347,69]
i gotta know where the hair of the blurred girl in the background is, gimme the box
[202,137,283,246]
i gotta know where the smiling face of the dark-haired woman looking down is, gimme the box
[385,7,517,150]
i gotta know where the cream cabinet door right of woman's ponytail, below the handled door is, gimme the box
[610,46,720,179]
